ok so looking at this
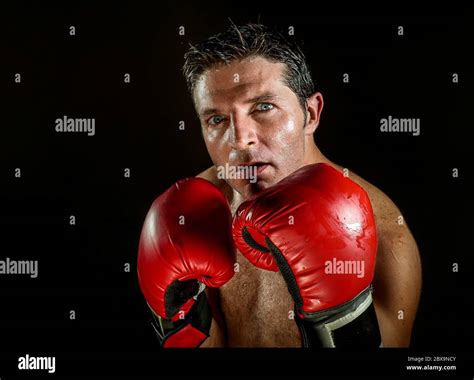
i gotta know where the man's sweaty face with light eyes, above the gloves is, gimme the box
[194,57,305,198]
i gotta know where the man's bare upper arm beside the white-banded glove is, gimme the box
[373,192,421,347]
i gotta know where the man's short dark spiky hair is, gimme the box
[183,23,314,110]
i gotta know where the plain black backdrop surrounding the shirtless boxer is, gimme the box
[0,2,474,379]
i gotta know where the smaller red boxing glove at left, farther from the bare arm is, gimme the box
[138,178,235,347]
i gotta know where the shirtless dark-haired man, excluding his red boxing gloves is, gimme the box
[139,24,421,347]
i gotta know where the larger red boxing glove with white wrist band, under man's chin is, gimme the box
[233,164,381,347]
